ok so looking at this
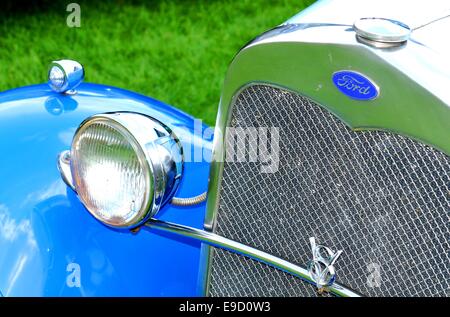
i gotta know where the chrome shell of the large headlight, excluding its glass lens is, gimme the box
[58,112,183,228]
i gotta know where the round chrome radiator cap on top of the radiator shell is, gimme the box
[353,18,411,47]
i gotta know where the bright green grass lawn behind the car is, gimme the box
[0,0,313,125]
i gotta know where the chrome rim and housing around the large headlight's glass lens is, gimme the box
[63,111,184,229]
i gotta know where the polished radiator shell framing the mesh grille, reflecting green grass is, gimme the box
[205,1,450,230]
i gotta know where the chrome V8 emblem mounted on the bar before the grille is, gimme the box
[308,237,342,293]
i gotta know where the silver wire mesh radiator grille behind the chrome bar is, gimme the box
[210,85,450,296]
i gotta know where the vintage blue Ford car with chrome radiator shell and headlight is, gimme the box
[0,0,450,296]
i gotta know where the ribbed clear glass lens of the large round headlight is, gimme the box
[72,118,152,226]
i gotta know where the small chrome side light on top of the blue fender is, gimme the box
[48,59,84,94]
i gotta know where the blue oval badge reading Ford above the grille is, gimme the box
[333,70,379,100]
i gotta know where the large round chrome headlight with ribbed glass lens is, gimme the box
[70,113,182,228]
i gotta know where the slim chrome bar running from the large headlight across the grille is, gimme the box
[145,218,361,297]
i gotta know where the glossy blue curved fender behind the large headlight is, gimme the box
[0,83,212,296]
